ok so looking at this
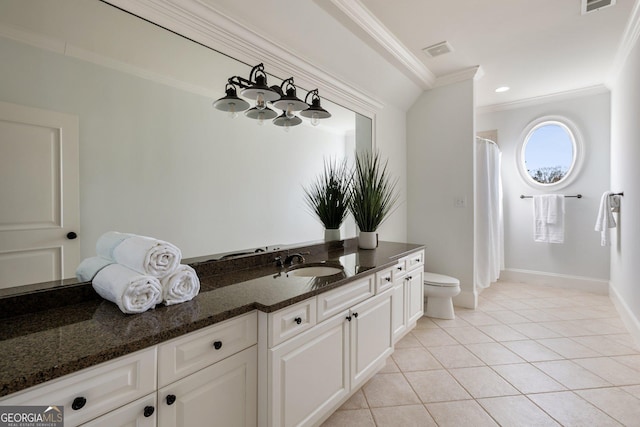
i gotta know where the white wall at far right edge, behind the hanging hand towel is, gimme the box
[610,29,640,341]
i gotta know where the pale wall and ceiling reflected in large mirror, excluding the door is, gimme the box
[0,0,372,287]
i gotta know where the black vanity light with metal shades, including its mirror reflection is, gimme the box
[213,64,331,131]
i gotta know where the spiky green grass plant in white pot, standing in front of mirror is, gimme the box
[349,152,399,249]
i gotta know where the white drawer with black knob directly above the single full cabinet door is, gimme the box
[158,311,258,387]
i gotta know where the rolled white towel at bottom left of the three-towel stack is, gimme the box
[92,264,162,314]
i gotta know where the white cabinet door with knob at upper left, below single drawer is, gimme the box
[158,345,258,427]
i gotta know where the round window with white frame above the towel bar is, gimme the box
[518,117,582,188]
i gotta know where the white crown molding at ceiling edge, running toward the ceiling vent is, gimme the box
[331,0,436,89]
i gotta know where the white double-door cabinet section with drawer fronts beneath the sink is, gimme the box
[259,275,393,427]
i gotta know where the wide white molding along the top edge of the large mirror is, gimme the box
[103,0,384,117]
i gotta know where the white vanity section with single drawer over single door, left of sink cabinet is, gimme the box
[157,312,258,427]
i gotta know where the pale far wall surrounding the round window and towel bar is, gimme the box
[476,92,610,290]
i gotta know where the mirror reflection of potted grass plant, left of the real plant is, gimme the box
[304,159,352,241]
